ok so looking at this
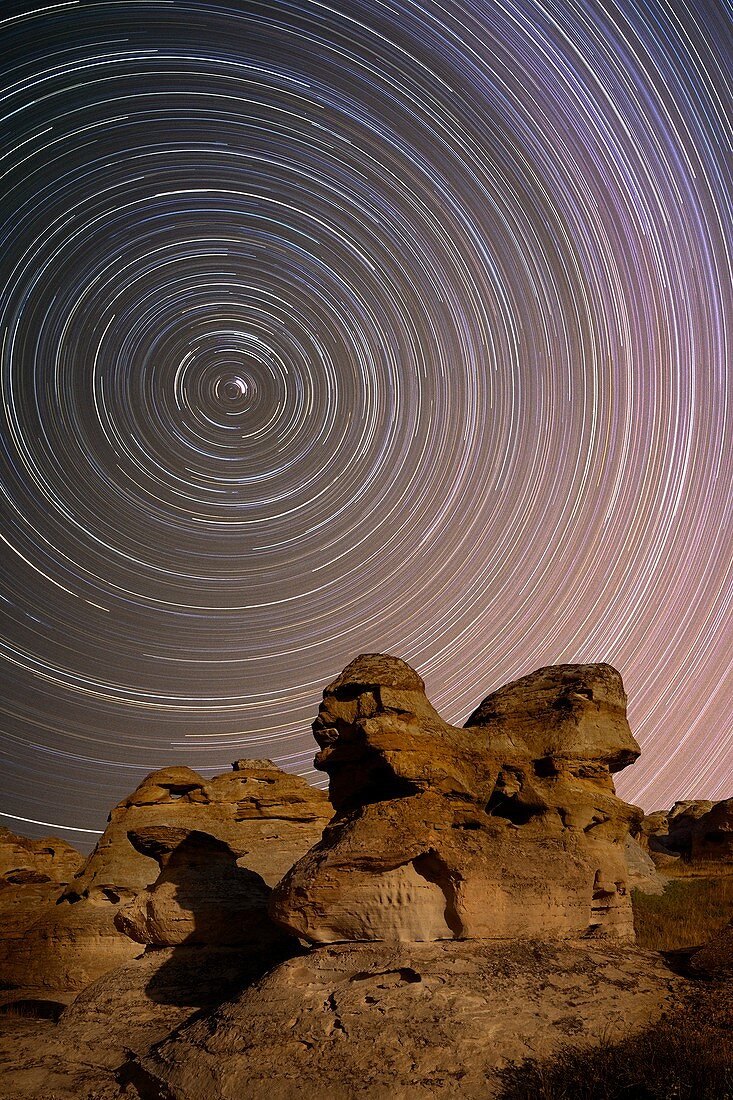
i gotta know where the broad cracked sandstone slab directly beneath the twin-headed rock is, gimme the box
[130,941,681,1100]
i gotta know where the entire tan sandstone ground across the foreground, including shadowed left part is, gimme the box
[0,939,683,1100]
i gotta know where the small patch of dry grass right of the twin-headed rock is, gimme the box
[633,875,733,952]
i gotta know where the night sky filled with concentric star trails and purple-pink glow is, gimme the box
[0,0,733,847]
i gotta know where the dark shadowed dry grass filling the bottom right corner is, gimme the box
[501,983,733,1100]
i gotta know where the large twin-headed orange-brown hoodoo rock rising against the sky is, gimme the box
[271,655,642,944]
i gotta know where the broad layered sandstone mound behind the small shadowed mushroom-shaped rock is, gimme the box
[0,760,332,990]
